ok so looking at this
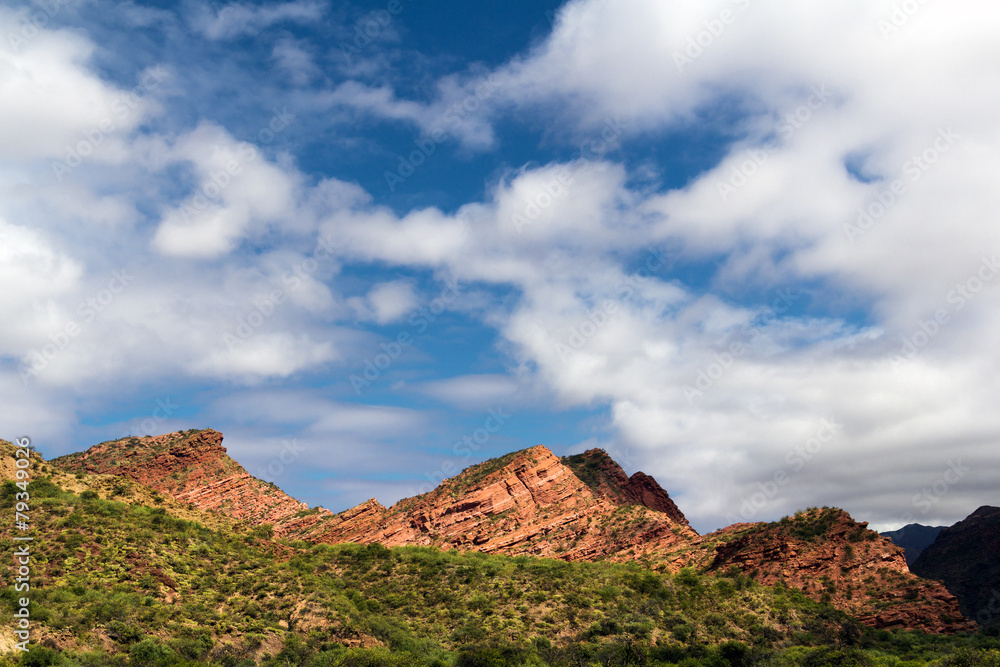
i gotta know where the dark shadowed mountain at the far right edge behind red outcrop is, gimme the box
[911,505,1000,627]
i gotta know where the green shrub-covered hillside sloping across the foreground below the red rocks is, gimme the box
[0,444,1000,667]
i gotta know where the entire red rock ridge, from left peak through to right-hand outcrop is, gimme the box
[53,430,973,632]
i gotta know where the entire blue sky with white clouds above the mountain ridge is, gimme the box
[0,0,1000,532]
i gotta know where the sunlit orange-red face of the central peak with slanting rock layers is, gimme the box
[285,446,697,560]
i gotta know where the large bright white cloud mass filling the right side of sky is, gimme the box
[306,0,1000,526]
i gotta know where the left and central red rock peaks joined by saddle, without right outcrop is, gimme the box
[53,429,696,560]
